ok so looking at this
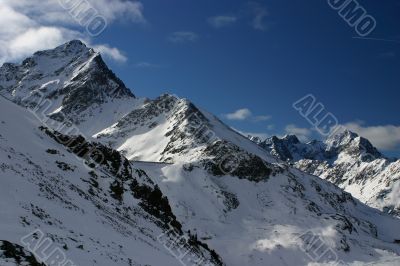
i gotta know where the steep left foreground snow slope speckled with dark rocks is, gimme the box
[0,97,222,266]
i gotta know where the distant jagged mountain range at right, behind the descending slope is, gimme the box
[252,131,400,216]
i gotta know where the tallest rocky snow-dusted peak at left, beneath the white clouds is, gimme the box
[0,40,135,129]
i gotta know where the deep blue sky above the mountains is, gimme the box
[0,0,400,156]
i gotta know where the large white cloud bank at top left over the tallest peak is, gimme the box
[0,0,145,64]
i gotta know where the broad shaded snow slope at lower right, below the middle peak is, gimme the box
[135,159,400,265]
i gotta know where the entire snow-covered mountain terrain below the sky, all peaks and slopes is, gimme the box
[0,41,400,266]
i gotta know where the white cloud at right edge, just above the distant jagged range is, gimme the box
[343,122,400,151]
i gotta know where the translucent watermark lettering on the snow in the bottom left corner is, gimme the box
[21,229,76,266]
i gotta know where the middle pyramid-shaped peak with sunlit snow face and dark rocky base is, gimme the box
[94,94,275,180]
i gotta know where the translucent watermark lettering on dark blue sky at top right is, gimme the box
[328,0,377,37]
